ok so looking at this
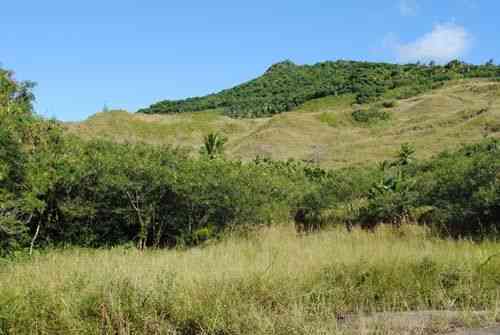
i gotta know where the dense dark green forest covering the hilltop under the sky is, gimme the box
[138,60,500,118]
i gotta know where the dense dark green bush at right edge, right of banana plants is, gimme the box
[415,140,500,236]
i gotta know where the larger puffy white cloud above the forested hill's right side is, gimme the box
[392,23,472,63]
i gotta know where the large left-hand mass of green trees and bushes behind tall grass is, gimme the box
[0,69,312,255]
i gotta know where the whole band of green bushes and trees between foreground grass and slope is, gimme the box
[4,63,500,255]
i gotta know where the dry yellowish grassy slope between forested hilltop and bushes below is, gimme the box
[68,80,500,167]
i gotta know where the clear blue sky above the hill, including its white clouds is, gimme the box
[0,0,500,120]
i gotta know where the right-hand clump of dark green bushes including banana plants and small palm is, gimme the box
[360,140,500,237]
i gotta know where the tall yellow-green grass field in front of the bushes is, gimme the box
[0,226,500,334]
